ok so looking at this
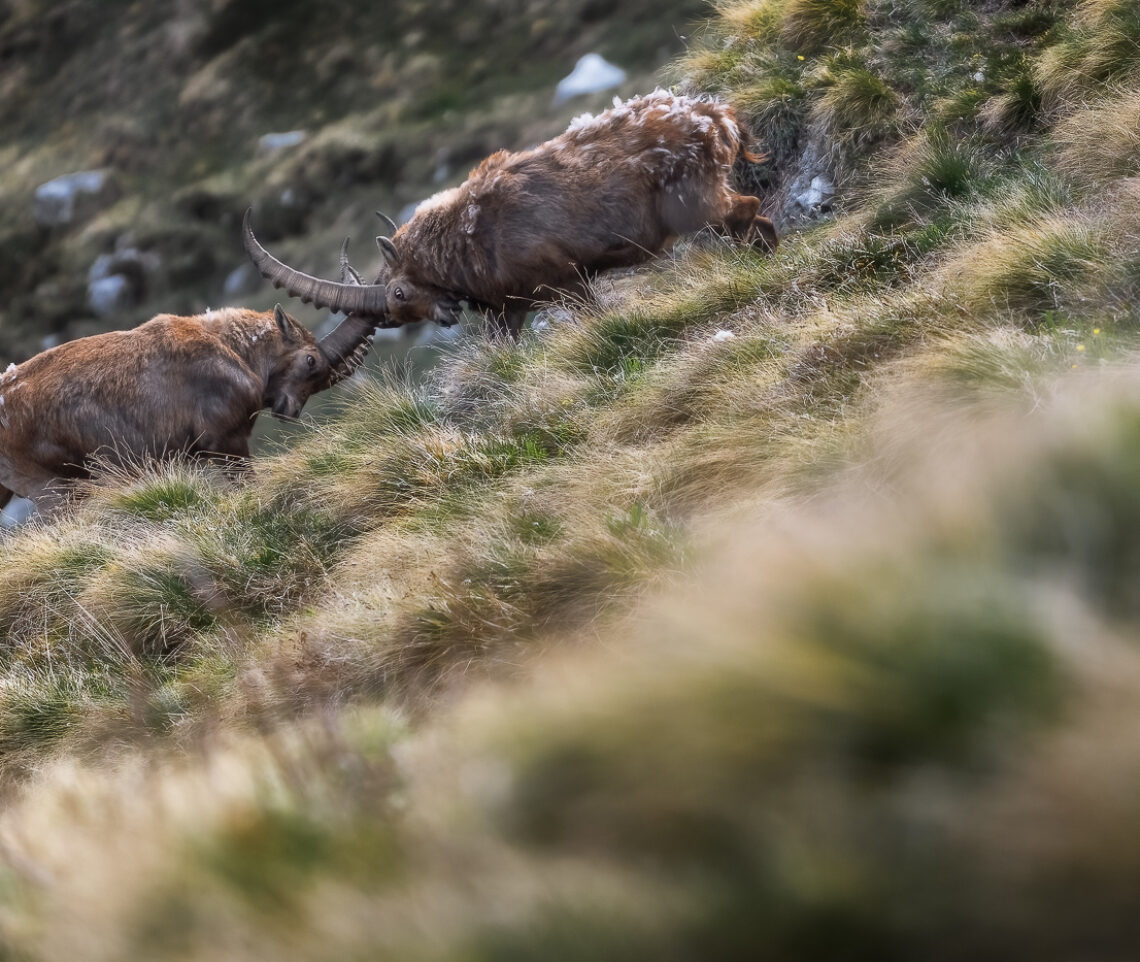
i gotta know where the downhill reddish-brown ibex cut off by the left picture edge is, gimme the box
[0,304,374,512]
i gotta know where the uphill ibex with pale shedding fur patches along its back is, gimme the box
[243,90,776,336]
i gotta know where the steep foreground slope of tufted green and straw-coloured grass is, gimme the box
[0,0,1140,960]
